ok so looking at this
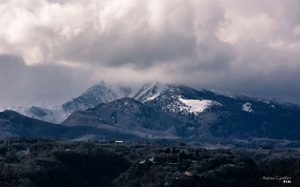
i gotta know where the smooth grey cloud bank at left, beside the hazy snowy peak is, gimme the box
[0,55,90,105]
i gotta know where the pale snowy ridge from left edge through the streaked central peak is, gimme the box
[0,81,170,123]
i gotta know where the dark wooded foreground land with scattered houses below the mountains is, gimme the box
[0,140,300,187]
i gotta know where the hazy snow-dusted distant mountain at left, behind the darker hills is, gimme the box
[0,82,132,123]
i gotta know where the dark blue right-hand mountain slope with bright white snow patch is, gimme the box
[145,85,300,139]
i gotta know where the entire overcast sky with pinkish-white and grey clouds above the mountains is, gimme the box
[0,0,300,104]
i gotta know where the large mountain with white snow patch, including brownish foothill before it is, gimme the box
[63,83,300,140]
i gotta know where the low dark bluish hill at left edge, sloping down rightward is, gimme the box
[0,110,137,140]
